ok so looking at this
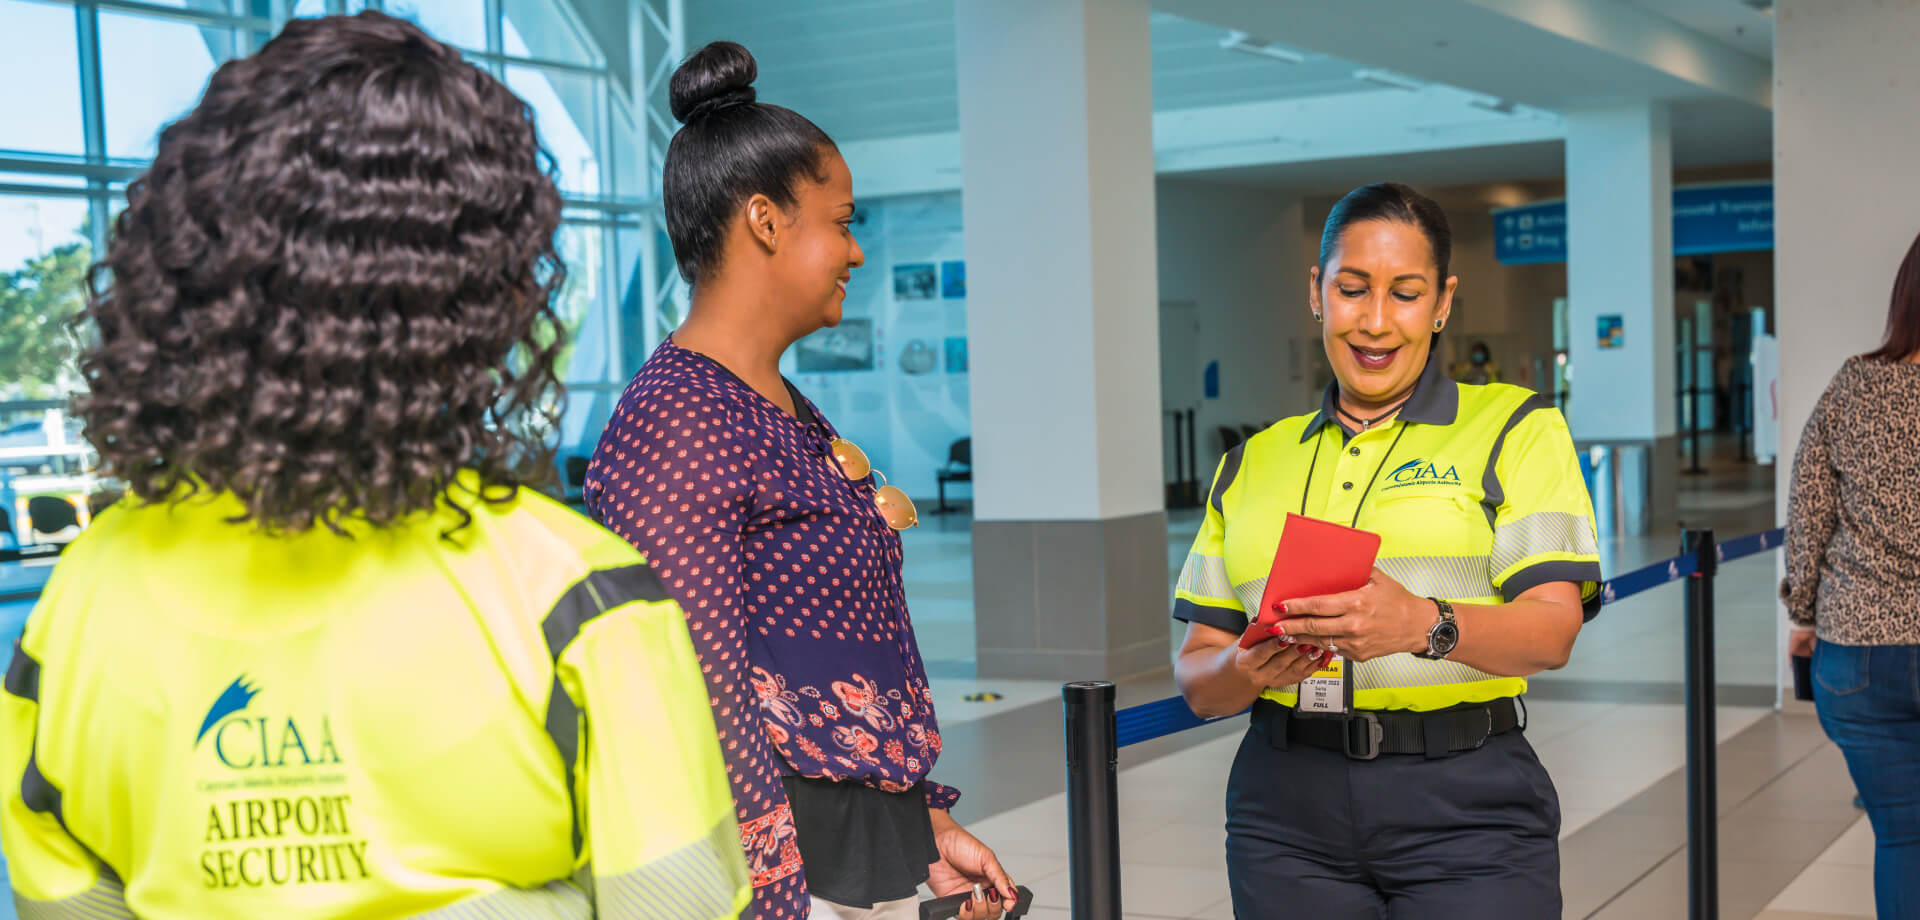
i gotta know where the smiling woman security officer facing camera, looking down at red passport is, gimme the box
[1173,184,1599,920]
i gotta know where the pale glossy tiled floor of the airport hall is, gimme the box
[908,449,1872,920]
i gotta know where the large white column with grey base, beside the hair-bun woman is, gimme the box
[954,0,1167,678]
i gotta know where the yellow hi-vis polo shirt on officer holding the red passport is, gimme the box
[1173,353,1599,711]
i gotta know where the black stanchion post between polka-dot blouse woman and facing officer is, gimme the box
[1060,680,1119,920]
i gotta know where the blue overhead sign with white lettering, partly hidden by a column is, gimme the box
[1494,182,1774,265]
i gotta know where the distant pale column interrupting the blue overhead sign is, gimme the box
[1567,102,1678,528]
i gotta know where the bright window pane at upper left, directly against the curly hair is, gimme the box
[100,10,238,159]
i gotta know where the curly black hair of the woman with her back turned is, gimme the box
[77,12,566,532]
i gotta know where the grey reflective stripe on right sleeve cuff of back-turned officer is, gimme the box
[593,814,747,920]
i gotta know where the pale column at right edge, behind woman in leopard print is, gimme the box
[1763,0,1920,706]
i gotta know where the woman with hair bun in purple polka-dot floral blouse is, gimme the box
[586,42,1014,920]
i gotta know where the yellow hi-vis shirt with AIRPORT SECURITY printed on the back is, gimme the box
[0,474,751,920]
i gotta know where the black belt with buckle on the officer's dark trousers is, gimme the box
[1254,697,1524,761]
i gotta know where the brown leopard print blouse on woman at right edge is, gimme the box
[1780,357,1920,645]
